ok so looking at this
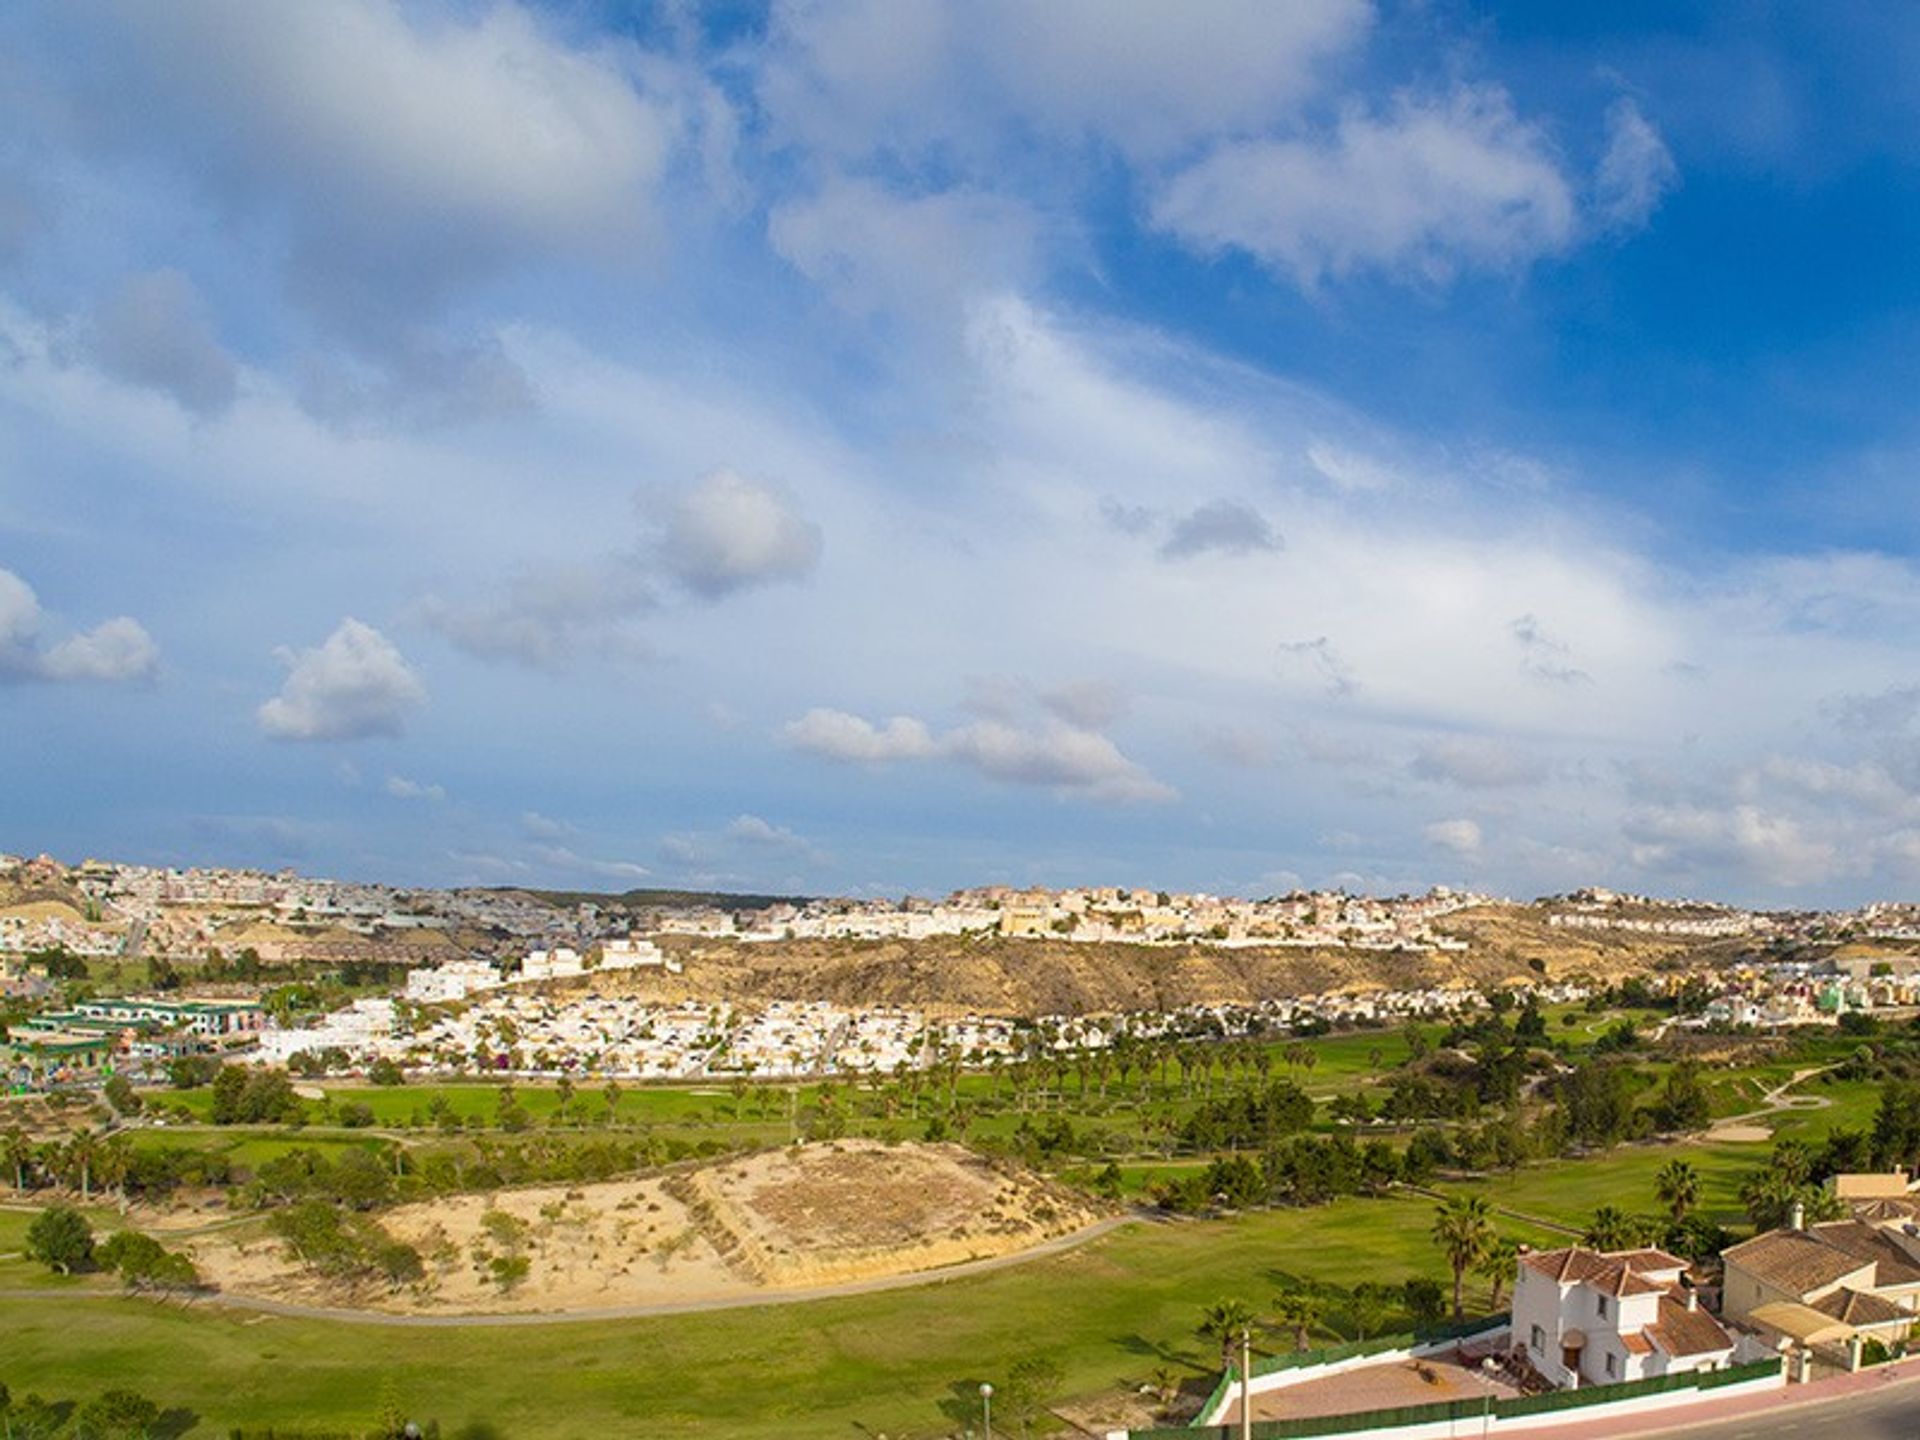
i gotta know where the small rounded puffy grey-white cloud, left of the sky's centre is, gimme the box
[660,470,820,599]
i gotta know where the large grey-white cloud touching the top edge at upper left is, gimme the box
[84,0,680,320]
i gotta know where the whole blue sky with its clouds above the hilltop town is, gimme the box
[0,0,1920,904]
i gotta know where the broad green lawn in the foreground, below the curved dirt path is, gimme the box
[0,1198,1551,1440]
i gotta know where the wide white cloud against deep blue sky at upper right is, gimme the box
[1152,84,1576,288]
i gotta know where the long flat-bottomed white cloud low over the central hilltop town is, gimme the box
[781,708,1177,801]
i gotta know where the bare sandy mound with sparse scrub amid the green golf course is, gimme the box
[188,1140,1100,1315]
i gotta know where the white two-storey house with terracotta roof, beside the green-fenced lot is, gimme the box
[1513,1246,1734,1390]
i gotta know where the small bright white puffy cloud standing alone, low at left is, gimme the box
[255,616,426,741]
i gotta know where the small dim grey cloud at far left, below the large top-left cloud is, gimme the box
[92,271,238,417]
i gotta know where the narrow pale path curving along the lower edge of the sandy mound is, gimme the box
[0,1213,1146,1331]
